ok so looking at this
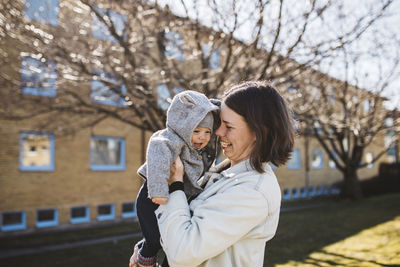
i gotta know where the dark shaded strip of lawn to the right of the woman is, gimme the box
[264,194,400,267]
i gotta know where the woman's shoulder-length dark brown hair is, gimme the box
[222,81,295,173]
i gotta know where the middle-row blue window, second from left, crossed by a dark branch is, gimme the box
[90,71,126,107]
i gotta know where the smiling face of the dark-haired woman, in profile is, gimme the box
[215,103,256,165]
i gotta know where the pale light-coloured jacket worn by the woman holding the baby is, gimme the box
[156,160,281,267]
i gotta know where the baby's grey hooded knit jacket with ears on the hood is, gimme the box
[138,91,219,198]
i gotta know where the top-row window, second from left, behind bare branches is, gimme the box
[92,7,127,43]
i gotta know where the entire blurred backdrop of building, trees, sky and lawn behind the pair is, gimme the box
[0,0,400,266]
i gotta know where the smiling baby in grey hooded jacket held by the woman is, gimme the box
[136,91,219,266]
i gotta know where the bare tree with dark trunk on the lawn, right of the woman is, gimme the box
[292,36,400,199]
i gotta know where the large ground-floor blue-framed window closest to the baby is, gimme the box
[90,136,125,171]
